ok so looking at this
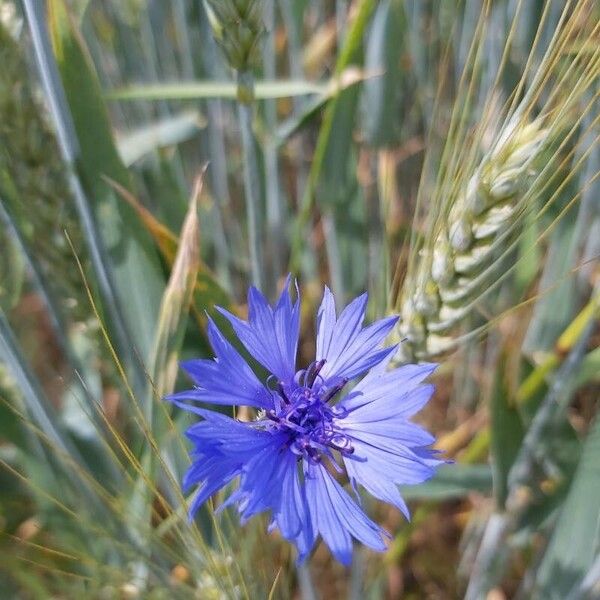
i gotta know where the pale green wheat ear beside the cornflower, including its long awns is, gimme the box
[396,2,600,361]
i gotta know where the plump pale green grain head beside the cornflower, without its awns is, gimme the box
[400,119,548,358]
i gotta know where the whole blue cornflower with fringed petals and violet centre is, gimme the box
[169,278,443,564]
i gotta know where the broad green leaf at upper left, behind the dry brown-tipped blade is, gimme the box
[48,0,164,359]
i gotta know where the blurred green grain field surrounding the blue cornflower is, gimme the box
[0,0,600,600]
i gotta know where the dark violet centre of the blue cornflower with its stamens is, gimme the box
[266,361,354,462]
